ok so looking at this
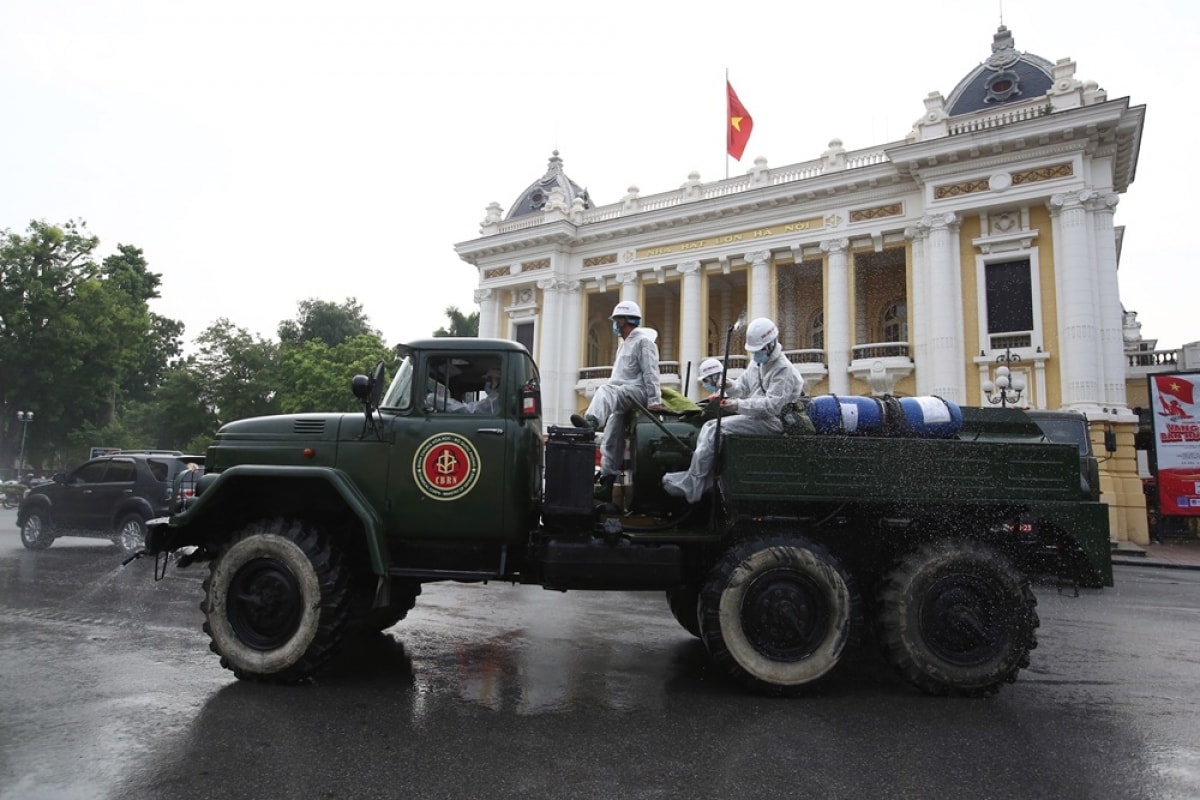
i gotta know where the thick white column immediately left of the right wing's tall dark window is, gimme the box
[920,212,966,403]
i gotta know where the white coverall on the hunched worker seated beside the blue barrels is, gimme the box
[662,342,804,503]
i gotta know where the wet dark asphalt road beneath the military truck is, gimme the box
[0,511,1200,800]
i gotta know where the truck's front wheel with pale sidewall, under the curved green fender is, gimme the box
[200,519,350,684]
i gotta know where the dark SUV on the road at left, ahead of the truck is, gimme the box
[17,450,204,554]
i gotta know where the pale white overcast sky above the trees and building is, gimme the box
[0,0,1200,348]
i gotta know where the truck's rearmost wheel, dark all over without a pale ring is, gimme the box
[876,542,1039,697]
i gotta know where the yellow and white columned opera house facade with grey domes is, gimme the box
[456,26,1148,543]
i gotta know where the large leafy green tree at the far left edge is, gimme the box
[0,221,182,468]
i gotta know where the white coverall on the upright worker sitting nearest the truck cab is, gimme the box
[586,327,662,475]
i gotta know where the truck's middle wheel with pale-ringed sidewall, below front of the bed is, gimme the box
[700,535,857,696]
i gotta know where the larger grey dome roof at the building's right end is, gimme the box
[946,25,1054,116]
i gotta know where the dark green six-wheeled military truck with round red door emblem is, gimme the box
[146,338,1112,696]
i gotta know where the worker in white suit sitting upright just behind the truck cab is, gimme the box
[571,300,662,500]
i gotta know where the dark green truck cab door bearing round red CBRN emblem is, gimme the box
[389,353,516,540]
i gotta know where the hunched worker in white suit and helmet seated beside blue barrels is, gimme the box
[662,317,804,503]
